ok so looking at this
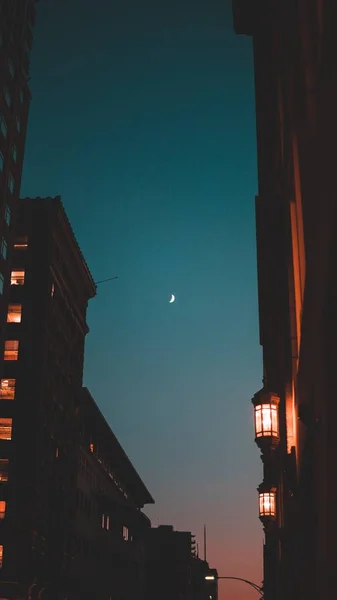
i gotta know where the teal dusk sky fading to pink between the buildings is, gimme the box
[22,0,263,600]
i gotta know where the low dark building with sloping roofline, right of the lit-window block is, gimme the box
[71,389,154,600]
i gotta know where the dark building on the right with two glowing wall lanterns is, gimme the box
[233,0,337,600]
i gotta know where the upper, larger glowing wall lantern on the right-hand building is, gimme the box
[252,389,280,447]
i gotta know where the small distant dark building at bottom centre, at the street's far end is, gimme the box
[145,525,217,600]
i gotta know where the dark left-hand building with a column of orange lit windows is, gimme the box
[0,197,96,597]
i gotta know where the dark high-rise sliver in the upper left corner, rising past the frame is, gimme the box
[0,0,35,369]
